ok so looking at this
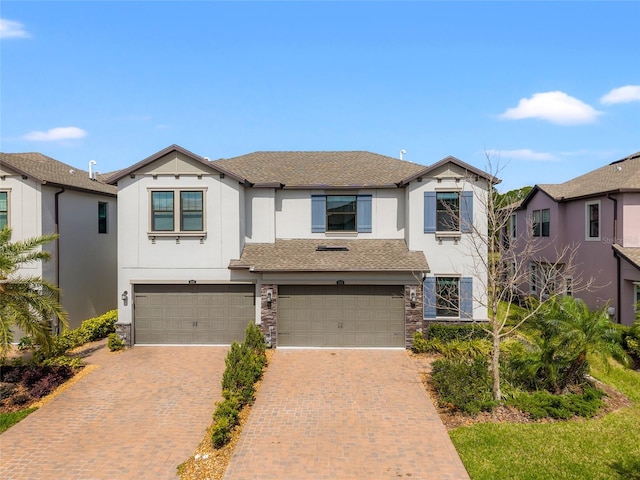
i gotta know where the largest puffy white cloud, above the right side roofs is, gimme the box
[500,91,602,125]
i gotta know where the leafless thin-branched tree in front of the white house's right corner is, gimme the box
[424,155,594,401]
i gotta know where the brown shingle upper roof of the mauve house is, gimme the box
[538,152,640,200]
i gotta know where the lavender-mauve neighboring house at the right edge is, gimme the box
[509,152,640,325]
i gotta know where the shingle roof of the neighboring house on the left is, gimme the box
[0,153,118,196]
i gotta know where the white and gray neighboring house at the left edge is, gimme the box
[0,153,117,328]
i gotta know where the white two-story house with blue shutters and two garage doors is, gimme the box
[109,145,490,348]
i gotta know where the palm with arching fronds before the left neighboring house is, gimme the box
[0,227,68,359]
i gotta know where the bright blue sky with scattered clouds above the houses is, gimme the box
[0,0,640,191]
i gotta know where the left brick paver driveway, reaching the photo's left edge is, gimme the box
[0,341,227,480]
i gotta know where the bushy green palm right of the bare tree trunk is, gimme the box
[520,297,630,393]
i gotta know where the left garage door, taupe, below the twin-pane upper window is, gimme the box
[134,285,255,345]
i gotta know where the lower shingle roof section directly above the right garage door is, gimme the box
[229,239,429,272]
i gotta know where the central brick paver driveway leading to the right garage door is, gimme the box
[224,349,469,480]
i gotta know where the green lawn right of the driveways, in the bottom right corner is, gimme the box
[450,361,640,480]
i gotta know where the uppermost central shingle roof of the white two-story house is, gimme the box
[212,151,425,188]
